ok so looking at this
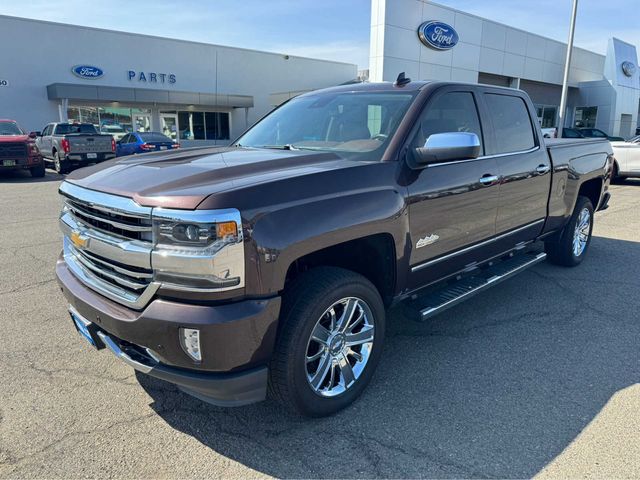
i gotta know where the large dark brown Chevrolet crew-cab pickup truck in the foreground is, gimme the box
[56,76,614,416]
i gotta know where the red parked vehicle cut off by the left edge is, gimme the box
[0,119,44,177]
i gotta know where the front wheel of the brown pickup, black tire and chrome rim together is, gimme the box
[269,267,385,417]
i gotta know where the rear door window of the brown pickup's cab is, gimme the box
[485,93,536,154]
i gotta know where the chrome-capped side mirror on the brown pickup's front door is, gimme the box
[413,132,480,166]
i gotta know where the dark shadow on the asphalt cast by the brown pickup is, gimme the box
[137,237,640,478]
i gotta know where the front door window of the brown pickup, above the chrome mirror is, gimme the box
[412,92,484,155]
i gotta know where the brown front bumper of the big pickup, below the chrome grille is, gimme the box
[56,258,280,406]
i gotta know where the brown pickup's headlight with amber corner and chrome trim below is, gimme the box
[151,208,244,291]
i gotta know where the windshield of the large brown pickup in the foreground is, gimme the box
[237,88,415,160]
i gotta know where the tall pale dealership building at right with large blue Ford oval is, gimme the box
[369,0,640,138]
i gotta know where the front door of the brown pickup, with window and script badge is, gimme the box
[407,87,499,289]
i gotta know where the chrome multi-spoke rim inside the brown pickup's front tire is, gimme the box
[305,297,374,397]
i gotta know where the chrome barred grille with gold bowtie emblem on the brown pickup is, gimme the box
[60,182,159,309]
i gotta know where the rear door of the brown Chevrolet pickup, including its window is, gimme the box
[483,89,551,242]
